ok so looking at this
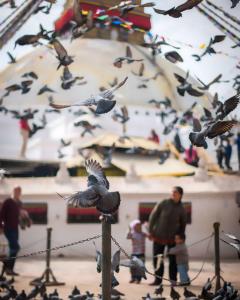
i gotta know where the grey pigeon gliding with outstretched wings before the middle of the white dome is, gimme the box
[49,77,128,114]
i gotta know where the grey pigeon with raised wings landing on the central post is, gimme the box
[57,159,121,214]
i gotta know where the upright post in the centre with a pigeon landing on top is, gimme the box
[102,217,112,300]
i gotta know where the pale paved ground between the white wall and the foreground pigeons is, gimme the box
[7,258,240,300]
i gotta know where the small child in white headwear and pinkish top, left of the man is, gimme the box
[127,220,147,283]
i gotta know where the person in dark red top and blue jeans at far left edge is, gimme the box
[0,186,22,276]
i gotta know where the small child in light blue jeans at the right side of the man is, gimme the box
[168,234,190,285]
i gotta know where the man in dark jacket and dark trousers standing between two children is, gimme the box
[149,186,186,285]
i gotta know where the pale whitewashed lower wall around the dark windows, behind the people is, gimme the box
[1,192,240,258]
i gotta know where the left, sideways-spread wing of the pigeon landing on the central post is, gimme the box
[58,186,101,207]
